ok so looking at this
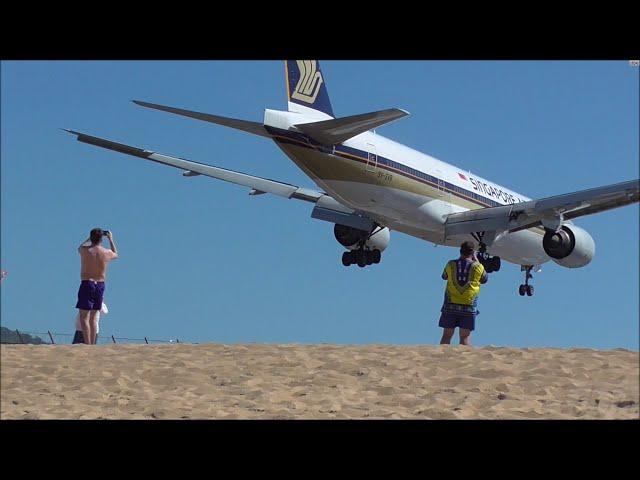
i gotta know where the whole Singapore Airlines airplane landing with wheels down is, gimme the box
[64,60,640,296]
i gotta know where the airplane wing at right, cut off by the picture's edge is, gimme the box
[445,180,640,242]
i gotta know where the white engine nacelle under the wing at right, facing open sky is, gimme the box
[542,225,596,268]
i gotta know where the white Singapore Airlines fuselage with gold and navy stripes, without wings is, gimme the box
[264,110,551,265]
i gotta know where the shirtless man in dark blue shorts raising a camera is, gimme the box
[76,228,118,345]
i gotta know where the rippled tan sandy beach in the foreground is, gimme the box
[0,344,640,419]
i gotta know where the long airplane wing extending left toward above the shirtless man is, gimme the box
[63,129,373,230]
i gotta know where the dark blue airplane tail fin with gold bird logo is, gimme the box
[285,60,335,119]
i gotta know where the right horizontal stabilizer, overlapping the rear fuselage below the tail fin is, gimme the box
[295,108,409,145]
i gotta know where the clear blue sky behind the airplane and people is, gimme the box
[1,61,640,350]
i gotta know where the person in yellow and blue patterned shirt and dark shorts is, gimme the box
[438,242,489,345]
